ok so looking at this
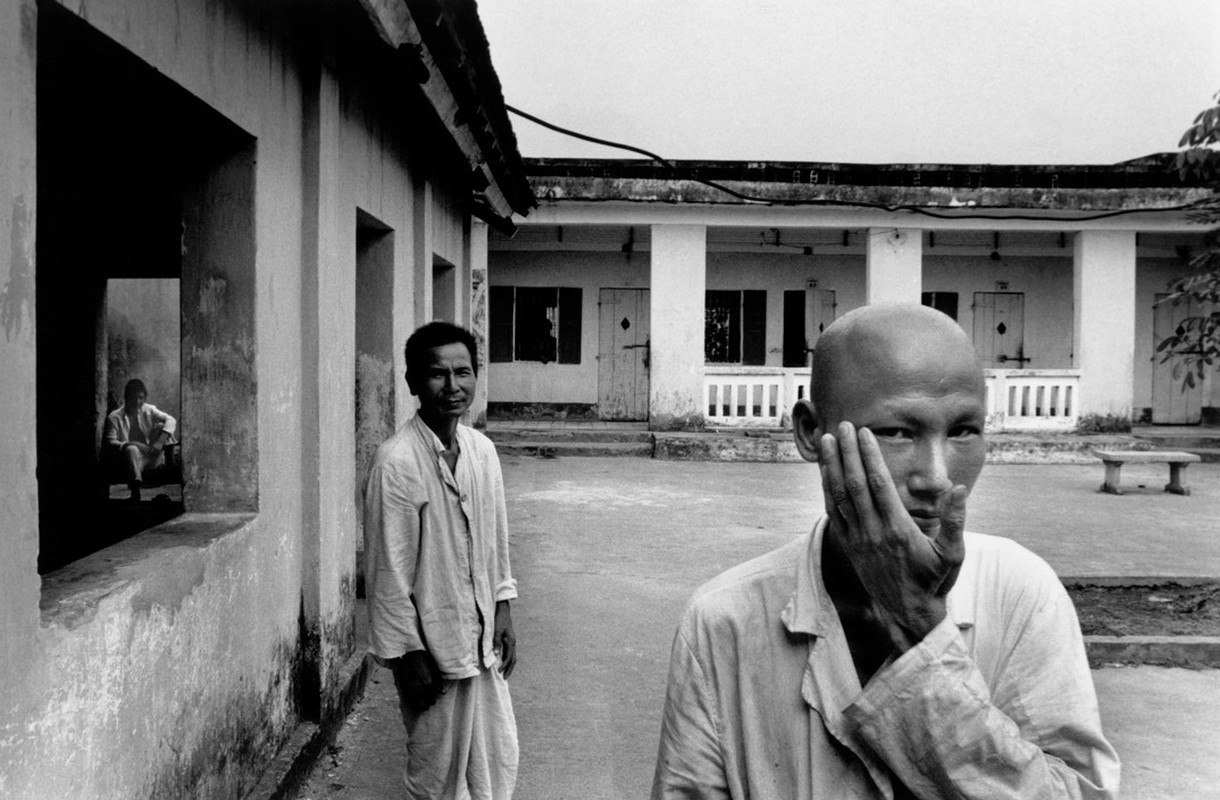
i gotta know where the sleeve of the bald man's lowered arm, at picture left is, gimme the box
[653,610,730,800]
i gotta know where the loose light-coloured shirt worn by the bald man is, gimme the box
[653,520,1119,800]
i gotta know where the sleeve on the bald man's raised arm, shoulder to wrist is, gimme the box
[847,567,1119,800]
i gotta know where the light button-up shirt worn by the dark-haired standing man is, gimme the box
[365,416,517,679]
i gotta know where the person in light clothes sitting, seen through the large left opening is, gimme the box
[102,378,178,500]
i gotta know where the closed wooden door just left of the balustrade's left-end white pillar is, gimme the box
[598,289,649,420]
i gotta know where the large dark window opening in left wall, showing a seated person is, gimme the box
[34,2,256,573]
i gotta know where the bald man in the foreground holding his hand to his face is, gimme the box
[653,305,1119,800]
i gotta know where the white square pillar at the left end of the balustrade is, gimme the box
[648,224,708,430]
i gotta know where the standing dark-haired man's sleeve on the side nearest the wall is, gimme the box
[365,463,426,661]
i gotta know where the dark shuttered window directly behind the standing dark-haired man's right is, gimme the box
[488,287,582,363]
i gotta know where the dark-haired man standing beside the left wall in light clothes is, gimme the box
[365,322,517,800]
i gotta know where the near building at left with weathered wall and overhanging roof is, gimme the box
[0,0,533,799]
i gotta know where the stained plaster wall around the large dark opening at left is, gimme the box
[0,0,468,798]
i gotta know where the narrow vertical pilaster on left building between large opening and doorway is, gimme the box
[296,68,357,720]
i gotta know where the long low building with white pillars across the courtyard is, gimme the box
[489,156,1220,429]
